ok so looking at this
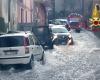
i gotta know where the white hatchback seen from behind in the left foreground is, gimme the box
[0,31,44,68]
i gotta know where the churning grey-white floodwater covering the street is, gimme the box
[0,30,100,80]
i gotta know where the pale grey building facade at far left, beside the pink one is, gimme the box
[0,0,17,30]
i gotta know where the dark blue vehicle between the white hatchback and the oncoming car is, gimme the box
[32,26,53,49]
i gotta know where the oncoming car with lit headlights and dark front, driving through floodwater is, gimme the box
[50,26,73,44]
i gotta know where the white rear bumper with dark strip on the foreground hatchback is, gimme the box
[0,56,31,65]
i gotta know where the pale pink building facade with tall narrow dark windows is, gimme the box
[17,0,33,23]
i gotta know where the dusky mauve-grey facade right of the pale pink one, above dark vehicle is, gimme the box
[34,0,47,26]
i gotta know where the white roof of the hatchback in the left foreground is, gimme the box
[0,31,32,37]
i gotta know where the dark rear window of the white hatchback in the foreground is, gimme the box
[0,36,24,47]
